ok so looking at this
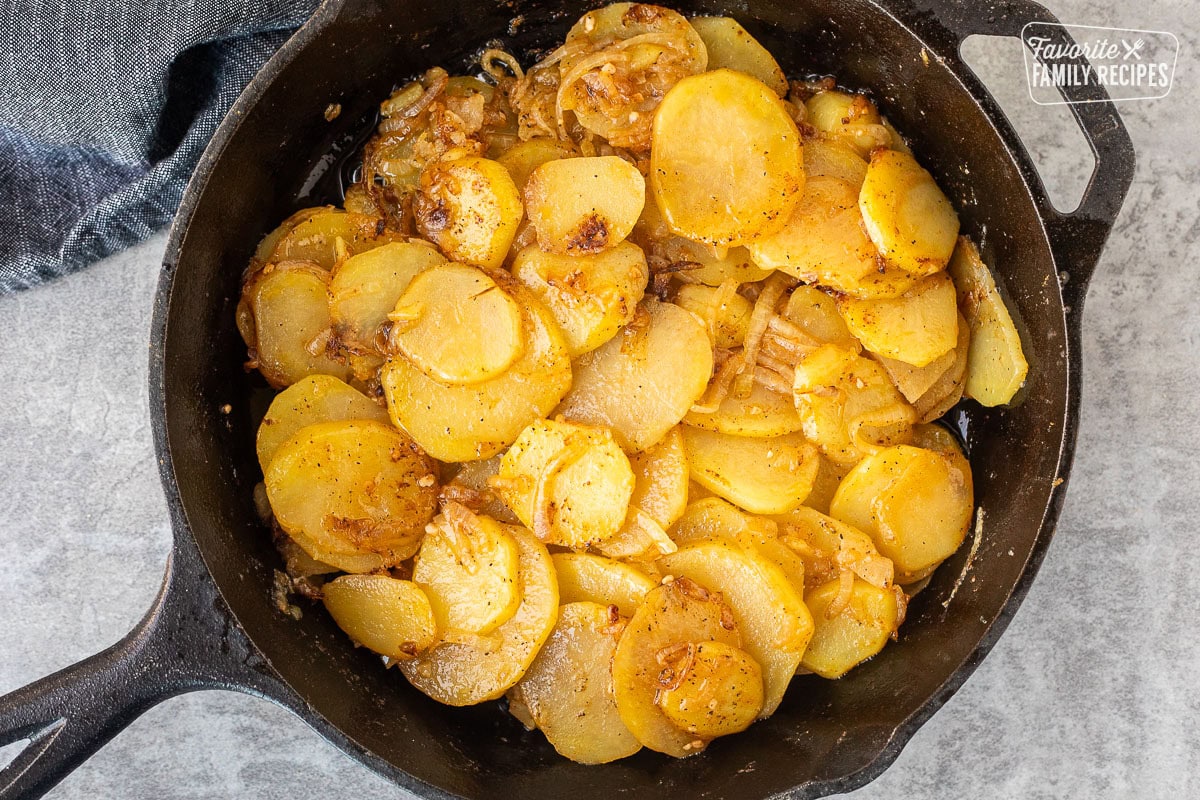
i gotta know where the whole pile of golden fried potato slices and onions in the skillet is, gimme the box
[236,2,1028,764]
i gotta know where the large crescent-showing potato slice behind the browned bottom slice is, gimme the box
[657,540,812,719]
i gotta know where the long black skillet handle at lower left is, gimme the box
[0,551,277,800]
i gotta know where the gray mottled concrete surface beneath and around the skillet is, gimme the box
[0,0,1200,800]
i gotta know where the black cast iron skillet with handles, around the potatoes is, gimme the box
[0,0,1134,800]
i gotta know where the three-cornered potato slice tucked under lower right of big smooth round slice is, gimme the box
[749,176,892,293]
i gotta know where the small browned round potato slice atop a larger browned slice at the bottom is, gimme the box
[658,642,763,739]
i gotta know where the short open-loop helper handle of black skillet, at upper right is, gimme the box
[918,0,1136,309]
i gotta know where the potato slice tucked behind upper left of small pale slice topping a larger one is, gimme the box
[329,240,446,348]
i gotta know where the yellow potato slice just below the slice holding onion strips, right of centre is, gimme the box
[683,426,817,513]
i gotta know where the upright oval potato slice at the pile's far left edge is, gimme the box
[242,261,350,389]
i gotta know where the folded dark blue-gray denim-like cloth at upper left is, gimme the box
[0,0,318,294]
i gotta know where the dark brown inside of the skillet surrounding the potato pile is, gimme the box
[162,0,1074,800]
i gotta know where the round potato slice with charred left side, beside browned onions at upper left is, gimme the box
[413,156,524,269]
